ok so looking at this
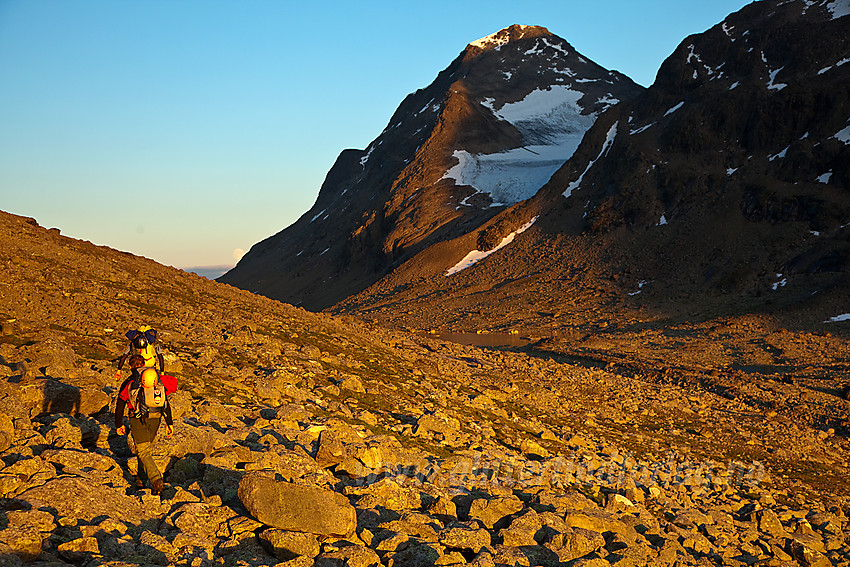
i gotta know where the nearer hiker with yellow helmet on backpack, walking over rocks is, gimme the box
[115,366,177,495]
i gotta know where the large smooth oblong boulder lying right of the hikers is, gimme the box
[238,473,357,537]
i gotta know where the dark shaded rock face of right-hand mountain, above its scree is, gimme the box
[528,2,850,306]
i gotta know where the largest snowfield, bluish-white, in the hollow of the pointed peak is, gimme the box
[443,85,600,205]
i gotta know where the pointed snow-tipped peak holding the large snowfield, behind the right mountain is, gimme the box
[220,26,642,309]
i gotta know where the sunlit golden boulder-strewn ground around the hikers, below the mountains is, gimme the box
[0,214,850,567]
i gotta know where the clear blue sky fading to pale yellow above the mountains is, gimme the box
[0,0,748,267]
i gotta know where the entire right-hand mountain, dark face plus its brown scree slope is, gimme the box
[334,1,850,340]
